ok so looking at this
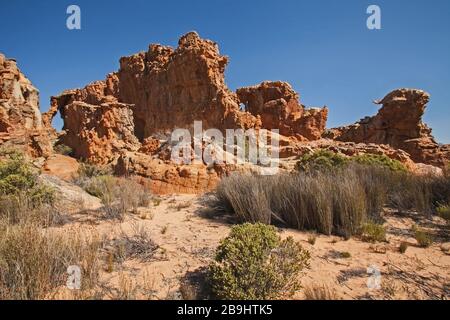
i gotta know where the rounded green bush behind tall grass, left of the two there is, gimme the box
[295,149,348,171]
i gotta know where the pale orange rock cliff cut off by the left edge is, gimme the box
[0,53,56,157]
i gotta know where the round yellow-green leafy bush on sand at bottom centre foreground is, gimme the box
[209,223,310,300]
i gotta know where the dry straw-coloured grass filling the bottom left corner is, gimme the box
[0,224,101,300]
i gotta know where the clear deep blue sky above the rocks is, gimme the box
[0,0,450,143]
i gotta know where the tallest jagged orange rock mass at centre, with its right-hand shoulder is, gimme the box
[48,32,327,163]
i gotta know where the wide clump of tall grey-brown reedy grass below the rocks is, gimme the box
[213,161,450,237]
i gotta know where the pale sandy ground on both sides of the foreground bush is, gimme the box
[57,195,450,299]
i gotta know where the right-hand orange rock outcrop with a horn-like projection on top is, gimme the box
[331,89,450,167]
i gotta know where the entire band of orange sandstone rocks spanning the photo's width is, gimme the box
[0,32,450,193]
